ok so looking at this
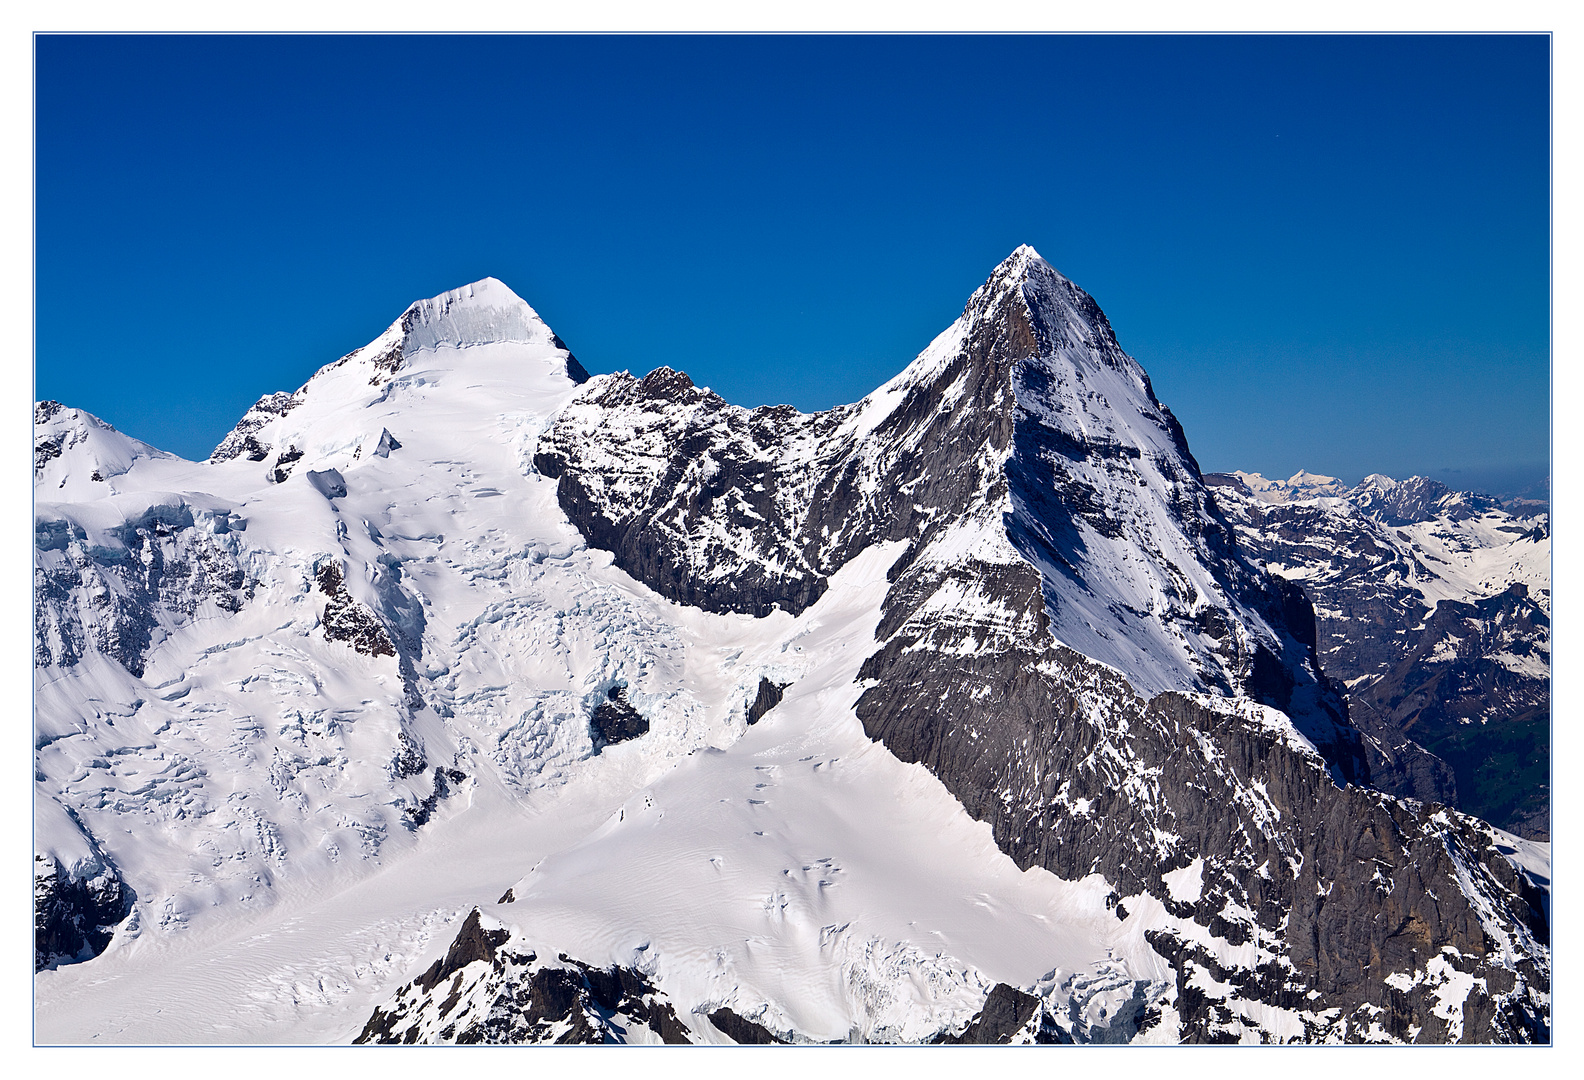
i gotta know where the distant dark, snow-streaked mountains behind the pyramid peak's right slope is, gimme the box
[1217,477,1551,839]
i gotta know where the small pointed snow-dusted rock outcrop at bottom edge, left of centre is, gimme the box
[353,907,693,1045]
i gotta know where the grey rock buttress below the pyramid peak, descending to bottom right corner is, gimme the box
[859,642,1549,1042]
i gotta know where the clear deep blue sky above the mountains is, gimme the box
[36,36,1549,488]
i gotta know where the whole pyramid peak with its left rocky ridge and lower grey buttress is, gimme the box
[535,250,1549,1042]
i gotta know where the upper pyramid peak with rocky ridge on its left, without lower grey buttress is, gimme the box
[535,247,1349,756]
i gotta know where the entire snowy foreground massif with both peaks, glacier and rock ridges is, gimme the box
[35,249,1549,1044]
